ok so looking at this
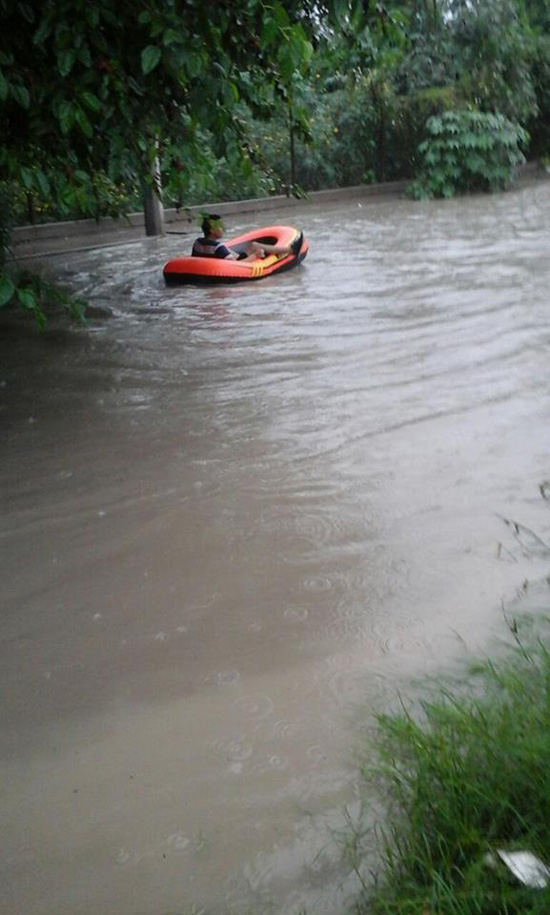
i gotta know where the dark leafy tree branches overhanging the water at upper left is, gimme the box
[0,0,312,326]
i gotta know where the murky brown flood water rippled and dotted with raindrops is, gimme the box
[0,183,550,915]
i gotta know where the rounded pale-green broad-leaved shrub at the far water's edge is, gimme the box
[410,111,528,198]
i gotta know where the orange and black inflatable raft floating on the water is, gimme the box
[163,226,309,285]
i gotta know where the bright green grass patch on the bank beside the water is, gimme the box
[357,622,550,915]
